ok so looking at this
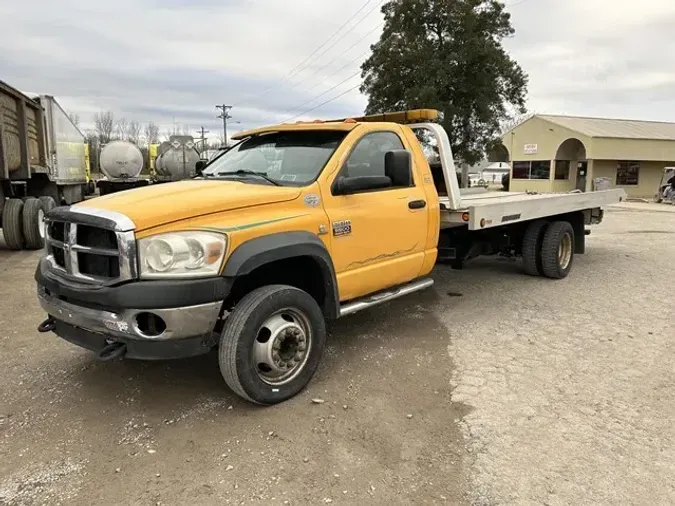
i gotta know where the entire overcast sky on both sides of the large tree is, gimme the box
[0,0,675,142]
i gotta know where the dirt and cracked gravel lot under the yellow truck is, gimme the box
[0,205,675,505]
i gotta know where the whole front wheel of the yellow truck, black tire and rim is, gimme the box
[218,285,326,405]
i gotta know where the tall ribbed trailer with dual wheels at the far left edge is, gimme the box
[0,81,87,250]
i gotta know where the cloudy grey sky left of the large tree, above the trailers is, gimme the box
[0,0,381,139]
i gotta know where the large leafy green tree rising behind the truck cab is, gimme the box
[361,0,527,164]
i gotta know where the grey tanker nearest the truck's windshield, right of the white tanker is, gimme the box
[154,135,199,183]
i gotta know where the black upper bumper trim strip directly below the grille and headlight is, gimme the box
[35,258,233,310]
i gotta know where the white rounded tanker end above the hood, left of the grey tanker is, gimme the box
[96,141,150,195]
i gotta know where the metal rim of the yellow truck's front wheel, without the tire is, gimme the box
[253,308,312,386]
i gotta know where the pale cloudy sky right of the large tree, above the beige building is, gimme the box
[506,0,675,121]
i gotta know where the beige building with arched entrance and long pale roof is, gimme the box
[490,114,675,198]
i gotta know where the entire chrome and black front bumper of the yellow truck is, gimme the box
[35,256,230,360]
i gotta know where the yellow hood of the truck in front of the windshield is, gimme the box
[75,180,301,231]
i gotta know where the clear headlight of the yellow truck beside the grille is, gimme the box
[138,231,227,279]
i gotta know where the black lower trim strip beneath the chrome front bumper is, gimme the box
[53,320,216,360]
